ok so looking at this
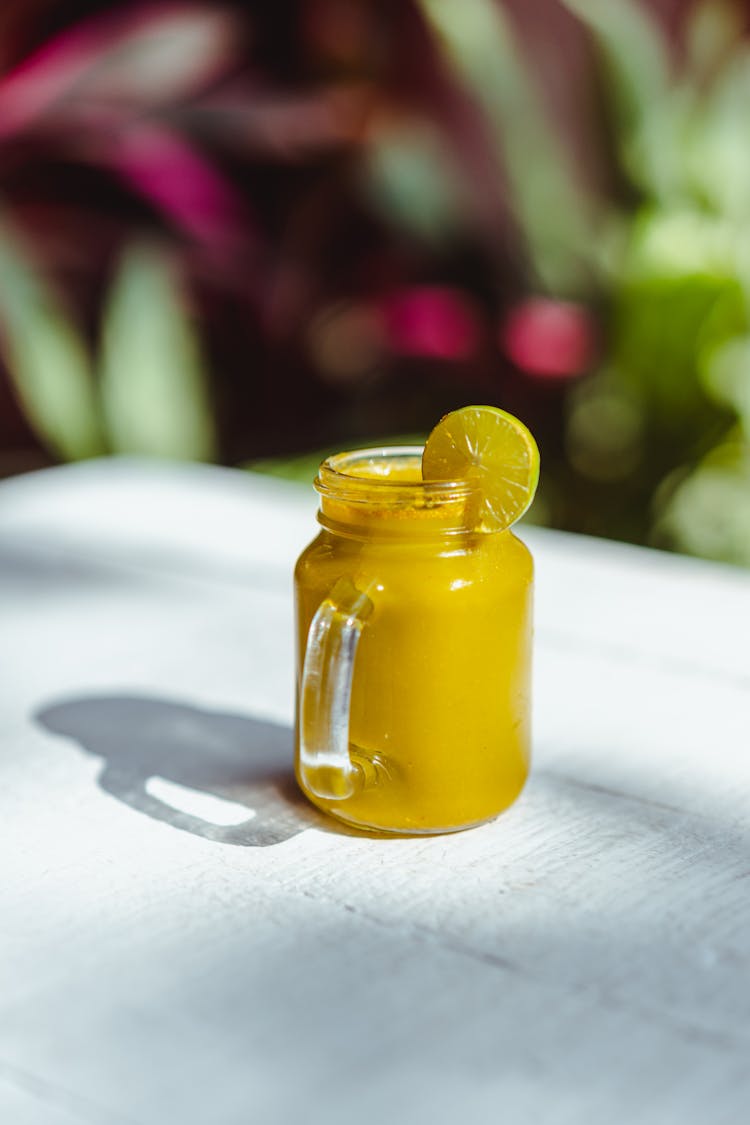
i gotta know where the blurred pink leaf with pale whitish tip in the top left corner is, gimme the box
[0,2,240,137]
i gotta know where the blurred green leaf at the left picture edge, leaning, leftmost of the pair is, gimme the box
[0,212,105,460]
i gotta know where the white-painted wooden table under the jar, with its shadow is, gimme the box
[0,461,750,1125]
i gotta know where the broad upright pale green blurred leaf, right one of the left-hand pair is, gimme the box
[101,245,215,460]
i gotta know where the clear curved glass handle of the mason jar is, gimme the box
[299,578,372,801]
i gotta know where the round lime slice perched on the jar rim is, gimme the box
[422,406,539,531]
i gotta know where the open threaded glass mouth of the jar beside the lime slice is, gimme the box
[315,446,476,507]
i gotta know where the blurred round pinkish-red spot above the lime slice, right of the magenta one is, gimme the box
[500,297,595,379]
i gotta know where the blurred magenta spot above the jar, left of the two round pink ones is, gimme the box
[380,286,479,360]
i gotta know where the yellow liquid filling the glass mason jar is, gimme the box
[296,464,533,834]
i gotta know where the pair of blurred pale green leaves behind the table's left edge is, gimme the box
[0,221,215,460]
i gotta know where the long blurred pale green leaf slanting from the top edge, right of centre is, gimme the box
[419,0,593,293]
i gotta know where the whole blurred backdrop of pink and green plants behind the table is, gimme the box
[0,0,750,565]
